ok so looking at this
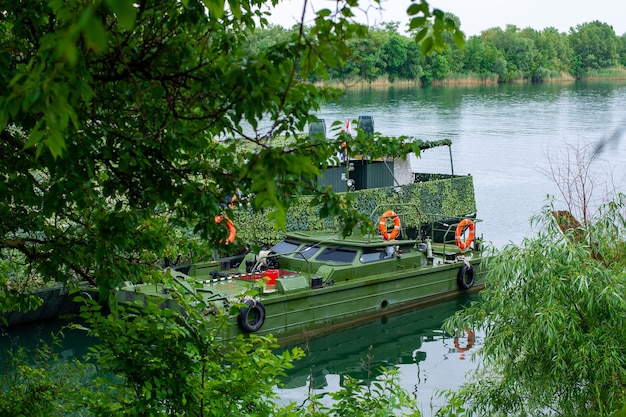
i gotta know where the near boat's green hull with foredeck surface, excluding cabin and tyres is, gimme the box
[118,252,486,344]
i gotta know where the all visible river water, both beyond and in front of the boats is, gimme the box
[0,82,626,416]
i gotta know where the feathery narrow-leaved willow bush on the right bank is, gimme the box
[438,196,626,416]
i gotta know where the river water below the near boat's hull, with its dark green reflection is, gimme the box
[278,294,481,408]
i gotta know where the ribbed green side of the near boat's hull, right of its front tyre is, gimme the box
[222,260,486,342]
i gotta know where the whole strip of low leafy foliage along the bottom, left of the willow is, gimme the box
[0,322,421,417]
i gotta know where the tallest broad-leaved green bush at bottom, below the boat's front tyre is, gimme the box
[77,294,303,416]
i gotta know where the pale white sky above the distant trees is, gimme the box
[270,0,626,37]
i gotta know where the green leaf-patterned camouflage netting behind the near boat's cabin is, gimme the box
[234,176,476,244]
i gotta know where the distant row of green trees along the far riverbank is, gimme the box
[249,16,626,85]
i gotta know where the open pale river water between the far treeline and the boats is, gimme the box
[318,81,626,247]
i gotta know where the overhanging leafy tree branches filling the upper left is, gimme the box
[0,0,436,308]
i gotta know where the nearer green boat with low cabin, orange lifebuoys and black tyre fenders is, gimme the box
[117,208,486,342]
